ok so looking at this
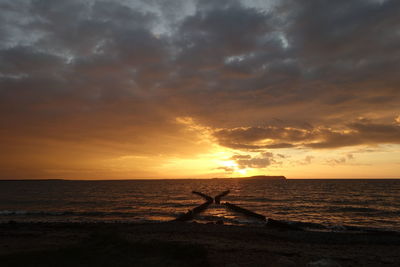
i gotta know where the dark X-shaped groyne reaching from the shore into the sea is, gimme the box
[175,190,266,221]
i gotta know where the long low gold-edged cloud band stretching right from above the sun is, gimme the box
[214,121,400,150]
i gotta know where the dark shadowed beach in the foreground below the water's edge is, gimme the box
[0,223,400,267]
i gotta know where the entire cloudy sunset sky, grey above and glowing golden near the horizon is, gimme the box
[0,0,400,179]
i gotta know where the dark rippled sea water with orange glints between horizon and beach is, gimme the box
[0,179,400,231]
